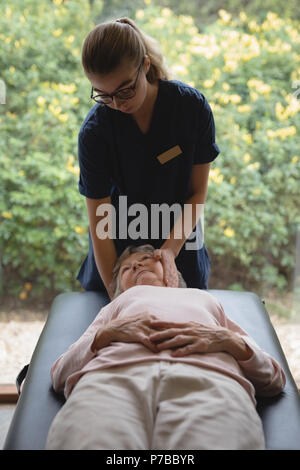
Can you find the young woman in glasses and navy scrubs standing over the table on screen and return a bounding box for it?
[77,18,219,298]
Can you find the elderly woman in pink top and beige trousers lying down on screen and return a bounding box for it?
[46,245,285,450]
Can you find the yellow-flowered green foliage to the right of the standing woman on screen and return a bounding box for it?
[137,7,300,288]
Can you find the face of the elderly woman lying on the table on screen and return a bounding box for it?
[119,252,166,291]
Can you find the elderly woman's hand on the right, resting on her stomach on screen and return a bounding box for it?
[149,320,232,357]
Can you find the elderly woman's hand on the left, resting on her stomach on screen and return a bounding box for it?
[91,311,159,353]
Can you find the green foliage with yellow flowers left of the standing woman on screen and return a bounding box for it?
[0,0,101,294]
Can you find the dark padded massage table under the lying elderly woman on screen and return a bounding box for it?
[4,290,300,450]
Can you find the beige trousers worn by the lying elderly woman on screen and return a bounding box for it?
[46,361,264,450]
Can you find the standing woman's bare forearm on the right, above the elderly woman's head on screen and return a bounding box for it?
[161,193,205,258]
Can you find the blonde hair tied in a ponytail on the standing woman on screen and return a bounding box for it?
[82,17,171,83]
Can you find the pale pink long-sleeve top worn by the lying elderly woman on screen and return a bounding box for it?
[51,285,286,405]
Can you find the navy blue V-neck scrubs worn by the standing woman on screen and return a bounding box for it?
[77,79,220,292]
